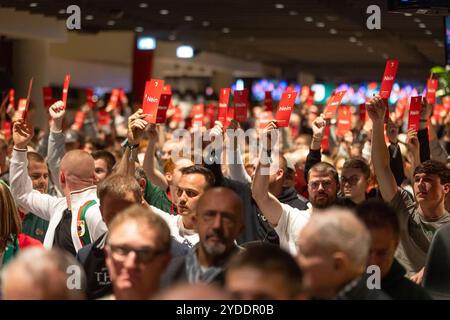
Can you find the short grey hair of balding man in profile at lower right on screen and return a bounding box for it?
[308,207,371,267]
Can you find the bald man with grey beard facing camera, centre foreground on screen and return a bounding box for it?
[162,187,244,286]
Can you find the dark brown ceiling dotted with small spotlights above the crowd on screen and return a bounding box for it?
[0,0,445,81]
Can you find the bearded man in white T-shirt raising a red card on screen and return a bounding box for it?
[252,122,339,255]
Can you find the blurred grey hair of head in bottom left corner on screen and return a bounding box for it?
[0,248,86,300]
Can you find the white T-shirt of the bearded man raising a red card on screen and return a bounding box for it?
[274,203,311,255]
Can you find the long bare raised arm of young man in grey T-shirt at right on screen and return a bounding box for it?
[366,96,397,202]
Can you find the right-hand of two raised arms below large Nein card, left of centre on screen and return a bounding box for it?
[143,124,169,190]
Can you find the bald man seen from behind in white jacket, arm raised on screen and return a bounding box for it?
[10,120,107,256]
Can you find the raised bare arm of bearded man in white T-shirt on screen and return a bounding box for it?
[252,121,283,227]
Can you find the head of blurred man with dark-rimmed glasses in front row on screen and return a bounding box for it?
[105,205,171,300]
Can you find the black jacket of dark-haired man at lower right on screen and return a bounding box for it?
[381,259,431,300]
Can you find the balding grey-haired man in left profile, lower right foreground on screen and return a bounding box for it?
[297,208,389,300]
